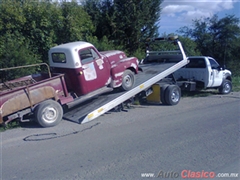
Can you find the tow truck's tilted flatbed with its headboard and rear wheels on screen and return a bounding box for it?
[63,37,188,124]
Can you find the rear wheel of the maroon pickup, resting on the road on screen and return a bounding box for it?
[35,100,63,127]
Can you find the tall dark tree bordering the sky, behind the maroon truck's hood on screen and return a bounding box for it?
[113,0,162,54]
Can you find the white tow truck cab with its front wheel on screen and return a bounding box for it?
[174,56,232,94]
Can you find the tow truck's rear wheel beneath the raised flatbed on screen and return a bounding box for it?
[165,85,181,105]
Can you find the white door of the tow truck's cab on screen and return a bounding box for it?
[208,58,223,87]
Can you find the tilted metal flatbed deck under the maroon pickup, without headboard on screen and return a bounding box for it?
[63,58,188,124]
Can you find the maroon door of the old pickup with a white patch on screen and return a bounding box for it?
[78,47,110,94]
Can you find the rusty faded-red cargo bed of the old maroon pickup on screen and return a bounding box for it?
[0,73,67,124]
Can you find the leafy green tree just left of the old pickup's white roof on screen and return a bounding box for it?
[21,0,61,62]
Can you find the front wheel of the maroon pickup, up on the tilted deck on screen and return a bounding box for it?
[121,69,135,91]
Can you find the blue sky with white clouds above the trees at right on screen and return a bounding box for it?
[159,0,240,35]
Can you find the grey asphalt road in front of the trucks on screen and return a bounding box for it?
[0,93,240,180]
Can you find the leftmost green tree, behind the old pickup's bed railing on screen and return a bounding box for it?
[0,0,39,80]
